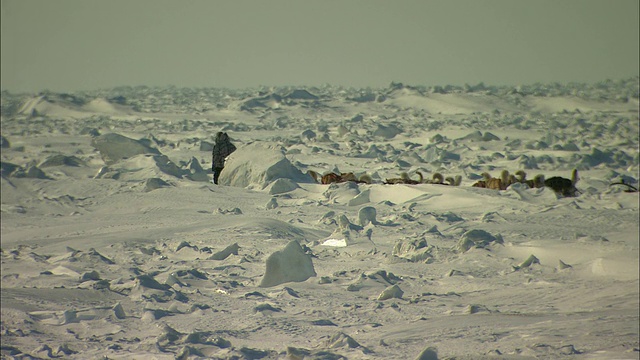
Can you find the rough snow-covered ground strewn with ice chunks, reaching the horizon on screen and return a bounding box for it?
[0,77,640,359]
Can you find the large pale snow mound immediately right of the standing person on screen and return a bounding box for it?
[218,143,310,190]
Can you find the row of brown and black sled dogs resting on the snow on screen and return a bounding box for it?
[307,169,580,197]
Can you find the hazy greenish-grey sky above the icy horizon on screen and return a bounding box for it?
[0,0,640,92]
